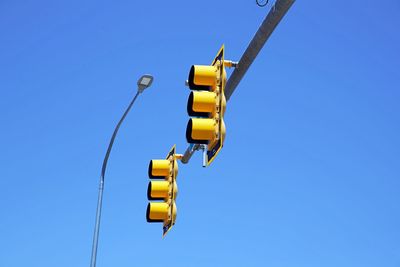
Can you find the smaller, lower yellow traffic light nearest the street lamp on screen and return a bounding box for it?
[146,146,181,236]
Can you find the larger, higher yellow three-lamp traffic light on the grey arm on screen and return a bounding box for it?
[186,45,227,165]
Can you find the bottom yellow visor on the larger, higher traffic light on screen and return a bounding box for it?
[186,118,217,144]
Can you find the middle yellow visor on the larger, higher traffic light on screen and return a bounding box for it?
[187,91,217,117]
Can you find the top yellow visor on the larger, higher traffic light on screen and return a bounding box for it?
[188,65,218,91]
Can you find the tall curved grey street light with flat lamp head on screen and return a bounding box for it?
[90,74,153,267]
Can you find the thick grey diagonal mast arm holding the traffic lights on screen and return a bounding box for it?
[181,0,295,163]
